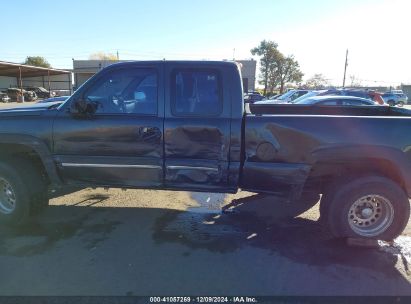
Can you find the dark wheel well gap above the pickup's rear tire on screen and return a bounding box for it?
[305,159,405,193]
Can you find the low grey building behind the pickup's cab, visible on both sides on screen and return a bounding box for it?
[73,60,257,91]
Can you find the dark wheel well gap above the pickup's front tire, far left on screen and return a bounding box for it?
[0,144,50,184]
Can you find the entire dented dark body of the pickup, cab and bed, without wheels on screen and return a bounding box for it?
[0,61,411,200]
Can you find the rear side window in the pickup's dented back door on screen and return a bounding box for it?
[171,70,222,116]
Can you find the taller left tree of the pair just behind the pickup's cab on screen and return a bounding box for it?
[251,40,279,95]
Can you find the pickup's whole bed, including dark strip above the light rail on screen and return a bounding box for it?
[242,105,411,196]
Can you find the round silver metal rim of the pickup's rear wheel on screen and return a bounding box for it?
[348,194,394,237]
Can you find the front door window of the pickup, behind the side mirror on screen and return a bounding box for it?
[84,68,157,115]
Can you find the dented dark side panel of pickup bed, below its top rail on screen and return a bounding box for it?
[241,115,411,192]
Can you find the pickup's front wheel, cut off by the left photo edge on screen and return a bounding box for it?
[0,160,30,226]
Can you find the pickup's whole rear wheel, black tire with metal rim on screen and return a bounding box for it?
[320,176,410,241]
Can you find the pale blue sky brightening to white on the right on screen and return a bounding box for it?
[0,0,411,86]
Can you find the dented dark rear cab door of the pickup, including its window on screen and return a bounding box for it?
[164,62,230,191]
